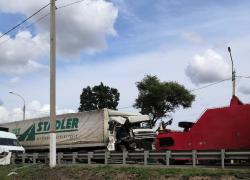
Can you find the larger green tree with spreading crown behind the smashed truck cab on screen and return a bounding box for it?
[133,75,195,126]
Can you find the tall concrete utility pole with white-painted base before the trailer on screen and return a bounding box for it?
[49,0,56,168]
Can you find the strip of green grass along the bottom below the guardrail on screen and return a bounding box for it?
[0,165,250,180]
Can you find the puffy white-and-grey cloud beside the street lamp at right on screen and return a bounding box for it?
[185,49,231,85]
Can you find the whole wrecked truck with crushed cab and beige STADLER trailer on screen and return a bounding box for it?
[0,109,155,152]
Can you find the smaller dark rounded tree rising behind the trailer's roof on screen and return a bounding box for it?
[78,82,120,112]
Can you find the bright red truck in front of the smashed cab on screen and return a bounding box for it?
[156,96,250,150]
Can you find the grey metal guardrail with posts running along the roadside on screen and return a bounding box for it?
[1,149,250,169]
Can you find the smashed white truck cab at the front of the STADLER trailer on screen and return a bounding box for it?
[107,110,155,151]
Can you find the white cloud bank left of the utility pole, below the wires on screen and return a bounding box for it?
[0,31,49,74]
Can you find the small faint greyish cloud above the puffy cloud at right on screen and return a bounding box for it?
[180,31,205,44]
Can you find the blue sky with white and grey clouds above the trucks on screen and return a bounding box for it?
[0,0,250,129]
